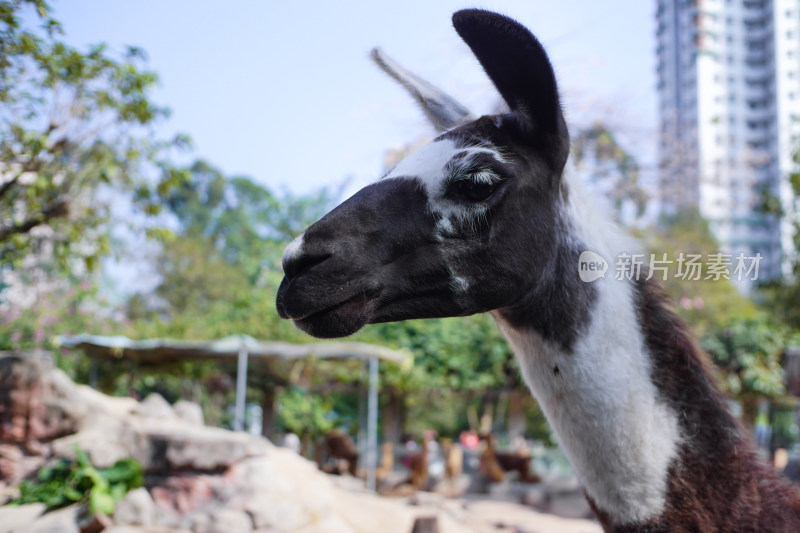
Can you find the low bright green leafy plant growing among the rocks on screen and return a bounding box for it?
[10,446,144,515]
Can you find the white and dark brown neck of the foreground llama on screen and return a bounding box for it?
[493,171,800,531]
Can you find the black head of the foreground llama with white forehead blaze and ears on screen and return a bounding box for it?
[277,10,585,343]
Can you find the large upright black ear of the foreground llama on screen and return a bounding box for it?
[453,9,566,135]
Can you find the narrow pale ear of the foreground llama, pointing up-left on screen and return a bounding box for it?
[370,48,474,132]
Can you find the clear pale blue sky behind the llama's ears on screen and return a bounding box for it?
[53,0,657,197]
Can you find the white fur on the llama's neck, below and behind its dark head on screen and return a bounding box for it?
[495,169,681,525]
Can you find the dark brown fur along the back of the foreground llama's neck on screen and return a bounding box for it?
[590,281,800,533]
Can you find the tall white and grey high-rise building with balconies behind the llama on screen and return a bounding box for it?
[656,0,800,279]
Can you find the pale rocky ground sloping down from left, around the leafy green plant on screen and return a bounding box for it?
[0,354,600,533]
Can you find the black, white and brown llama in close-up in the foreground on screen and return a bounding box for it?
[276,10,800,532]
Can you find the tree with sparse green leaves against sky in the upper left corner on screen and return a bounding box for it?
[0,0,188,270]
